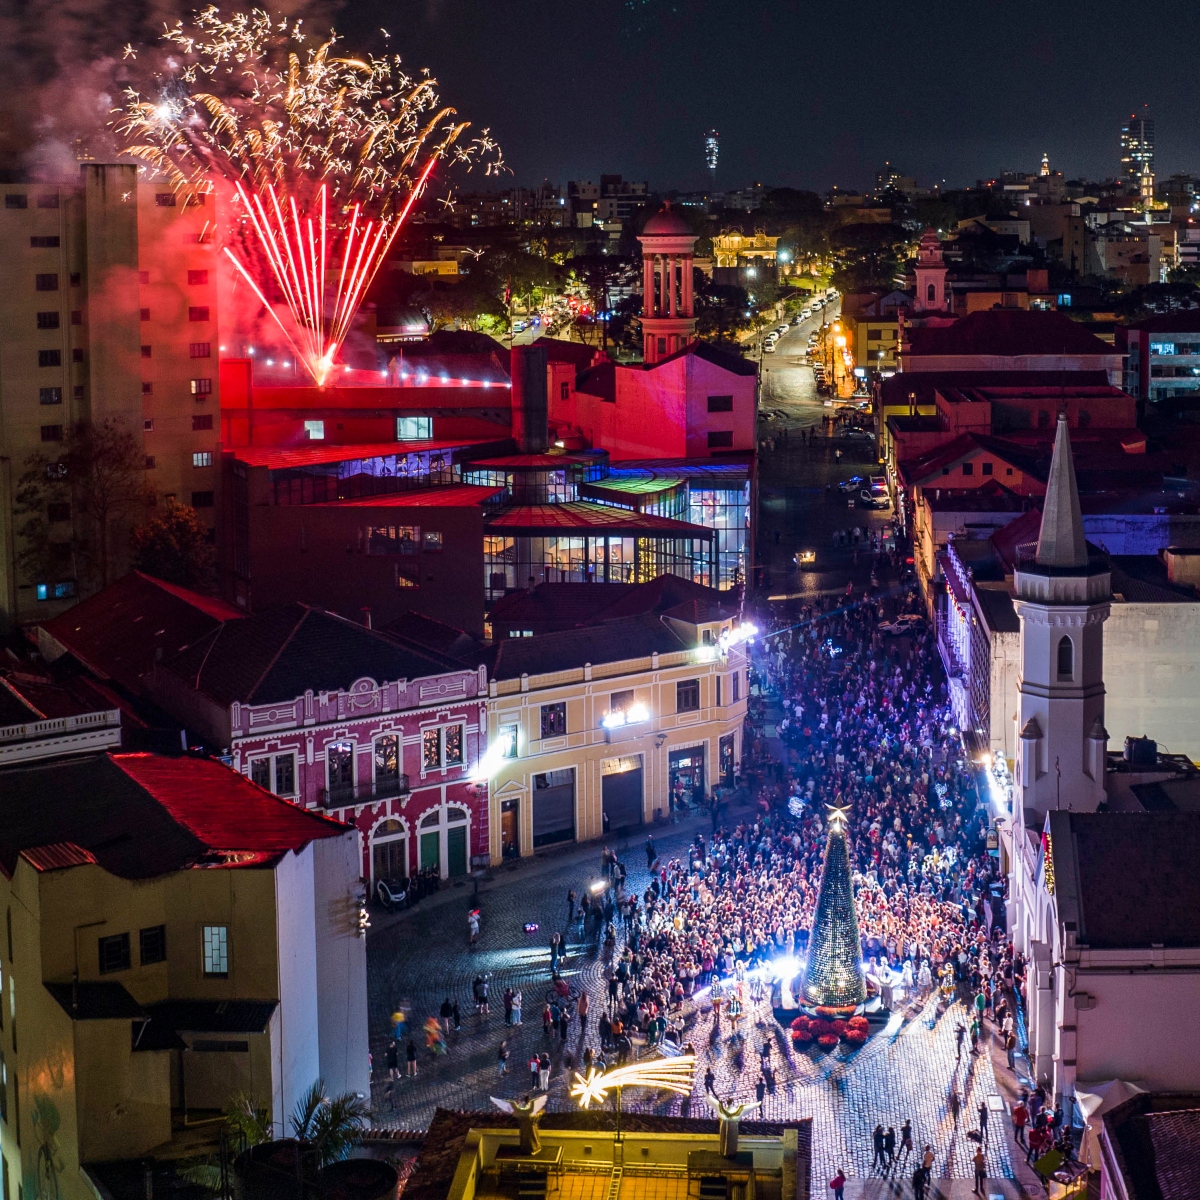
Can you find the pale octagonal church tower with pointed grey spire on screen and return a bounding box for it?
[1014,413,1112,832]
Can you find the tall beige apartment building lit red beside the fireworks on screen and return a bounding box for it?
[0,162,220,628]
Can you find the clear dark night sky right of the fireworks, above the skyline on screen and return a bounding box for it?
[337,0,1200,190]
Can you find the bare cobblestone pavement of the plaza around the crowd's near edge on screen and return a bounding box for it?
[368,809,1014,1180]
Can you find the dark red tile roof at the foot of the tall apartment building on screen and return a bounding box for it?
[38,571,246,694]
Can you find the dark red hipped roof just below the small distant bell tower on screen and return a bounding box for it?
[905,308,1120,361]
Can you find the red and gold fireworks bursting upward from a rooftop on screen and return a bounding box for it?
[116,7,502,384]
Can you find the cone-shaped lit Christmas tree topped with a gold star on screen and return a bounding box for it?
[804,805,866,1010]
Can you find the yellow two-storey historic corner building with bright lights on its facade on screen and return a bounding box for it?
[480,601,754,863]
